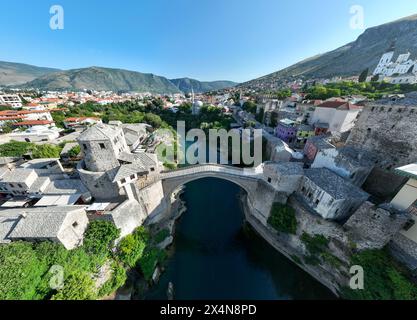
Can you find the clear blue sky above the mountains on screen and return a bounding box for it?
[0,0,417,81]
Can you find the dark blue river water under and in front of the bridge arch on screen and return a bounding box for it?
[146,178,335,300]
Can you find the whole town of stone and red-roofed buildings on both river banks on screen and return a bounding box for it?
[0,79,417,293]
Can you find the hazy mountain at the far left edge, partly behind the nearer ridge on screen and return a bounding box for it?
[0,61,59,86]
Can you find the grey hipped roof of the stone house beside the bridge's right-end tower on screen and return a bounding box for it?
[304,168,369,199]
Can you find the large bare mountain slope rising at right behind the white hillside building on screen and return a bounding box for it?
[241,14,417,87]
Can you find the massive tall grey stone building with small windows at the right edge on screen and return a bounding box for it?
[346,92,417,199]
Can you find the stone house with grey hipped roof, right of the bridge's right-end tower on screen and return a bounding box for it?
[297,168,369,220]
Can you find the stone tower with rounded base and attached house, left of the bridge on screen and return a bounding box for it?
[78,124,160,200]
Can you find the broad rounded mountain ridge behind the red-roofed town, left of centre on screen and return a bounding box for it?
[23,67,180,94]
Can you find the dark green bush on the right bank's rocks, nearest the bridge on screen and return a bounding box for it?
[268,203,297,234]
